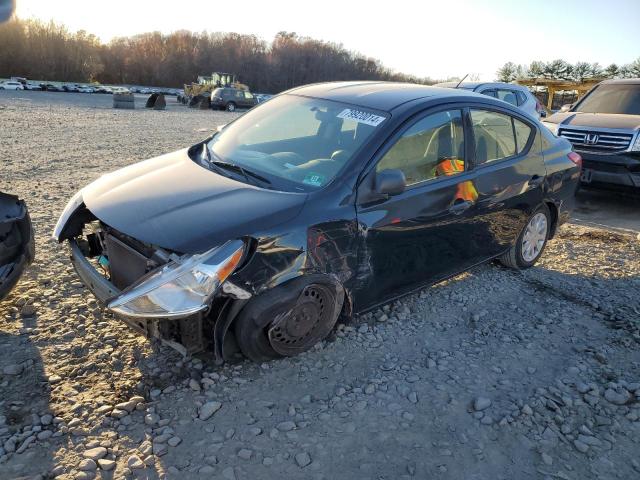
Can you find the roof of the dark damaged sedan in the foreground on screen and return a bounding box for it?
[285,82,469,112]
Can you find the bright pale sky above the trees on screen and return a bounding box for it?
[16,0,640,80]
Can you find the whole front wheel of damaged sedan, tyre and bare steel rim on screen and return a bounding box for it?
[235,275,344,362]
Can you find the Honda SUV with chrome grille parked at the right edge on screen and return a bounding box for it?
[543,78,640,191]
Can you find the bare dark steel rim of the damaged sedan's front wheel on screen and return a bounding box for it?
[268,285,334,355]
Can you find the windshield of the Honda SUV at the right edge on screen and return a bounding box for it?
[573,84,640,115]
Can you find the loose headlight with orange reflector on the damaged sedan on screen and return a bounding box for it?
[108,240,244,318]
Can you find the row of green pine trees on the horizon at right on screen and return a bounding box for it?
[496,57,640,82]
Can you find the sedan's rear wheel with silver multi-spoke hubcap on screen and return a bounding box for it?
[499,205,551,269]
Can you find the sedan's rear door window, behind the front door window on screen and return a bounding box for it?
[471,110,516,164]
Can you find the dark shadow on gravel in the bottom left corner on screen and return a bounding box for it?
[0,330,54,478]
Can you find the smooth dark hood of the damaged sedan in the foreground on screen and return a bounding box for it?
[82,149,307,253]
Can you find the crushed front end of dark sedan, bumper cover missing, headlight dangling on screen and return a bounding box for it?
[53,196,250,359]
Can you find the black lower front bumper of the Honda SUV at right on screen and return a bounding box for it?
[578,151,640,189]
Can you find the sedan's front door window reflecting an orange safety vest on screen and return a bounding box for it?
[376,110,465,185]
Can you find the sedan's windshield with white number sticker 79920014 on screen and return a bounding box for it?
[208,95,386,191]
